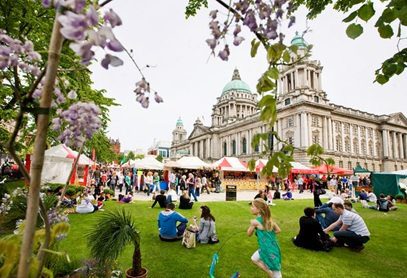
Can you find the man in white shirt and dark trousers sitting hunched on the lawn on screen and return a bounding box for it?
[324,204,370,252]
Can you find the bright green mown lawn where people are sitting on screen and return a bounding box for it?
[61,200,407,278]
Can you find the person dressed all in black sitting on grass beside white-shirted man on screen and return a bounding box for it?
[293,207,332,251]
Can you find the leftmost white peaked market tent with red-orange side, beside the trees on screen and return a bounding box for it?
[41,144,93,185]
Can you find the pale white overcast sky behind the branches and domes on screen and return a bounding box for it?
[91,0,407,151]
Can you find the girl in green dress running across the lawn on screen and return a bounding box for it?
[247,198,282,278]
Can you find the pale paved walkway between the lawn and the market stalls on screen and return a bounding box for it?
[116,190,328,202]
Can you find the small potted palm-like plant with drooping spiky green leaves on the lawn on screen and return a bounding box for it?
[87,208,148,278]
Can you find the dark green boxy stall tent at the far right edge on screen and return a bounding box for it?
[371,173,407,196]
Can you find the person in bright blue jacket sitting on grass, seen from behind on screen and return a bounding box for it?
[158,203,188,241]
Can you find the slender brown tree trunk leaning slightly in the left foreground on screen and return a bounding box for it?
[18,12,63,278]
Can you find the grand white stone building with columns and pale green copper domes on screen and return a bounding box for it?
[171,36,407,171]
